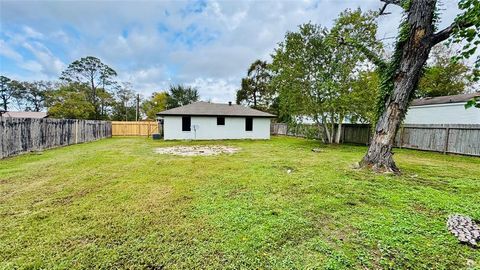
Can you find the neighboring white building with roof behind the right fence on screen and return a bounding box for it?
[404,93,480,124]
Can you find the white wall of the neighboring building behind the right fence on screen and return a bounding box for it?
[404,103,480,124]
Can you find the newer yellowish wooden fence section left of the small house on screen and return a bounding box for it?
[112,121,159,136]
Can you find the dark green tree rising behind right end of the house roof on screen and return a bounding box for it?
[236,60,274,110]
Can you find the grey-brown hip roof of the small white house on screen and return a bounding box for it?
[157,101,275,117]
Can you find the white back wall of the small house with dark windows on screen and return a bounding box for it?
[163,116,270,140]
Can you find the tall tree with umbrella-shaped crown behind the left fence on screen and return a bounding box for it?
[60,56,117,119]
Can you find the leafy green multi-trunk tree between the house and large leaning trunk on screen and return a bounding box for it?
[271,10,381,142]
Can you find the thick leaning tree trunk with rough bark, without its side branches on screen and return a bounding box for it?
[360,0,436,173]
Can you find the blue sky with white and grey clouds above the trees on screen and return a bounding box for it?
[0,0,459,102]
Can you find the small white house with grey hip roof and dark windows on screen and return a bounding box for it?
[157,101,275,140]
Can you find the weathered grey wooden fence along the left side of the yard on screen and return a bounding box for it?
[0,117,112,158]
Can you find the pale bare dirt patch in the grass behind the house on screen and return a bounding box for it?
[155,145,239,157]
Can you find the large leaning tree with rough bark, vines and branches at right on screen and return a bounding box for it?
[356,0,480,173]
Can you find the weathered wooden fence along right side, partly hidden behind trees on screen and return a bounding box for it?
[271,123,480,156]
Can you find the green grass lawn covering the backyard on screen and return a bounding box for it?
[0,137,480,269]
